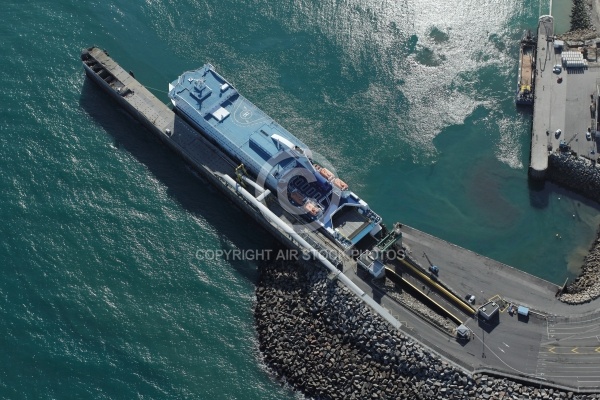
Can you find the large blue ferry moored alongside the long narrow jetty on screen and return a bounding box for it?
[169,64,385,250]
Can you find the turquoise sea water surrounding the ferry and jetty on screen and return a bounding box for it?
[0,0,600,399]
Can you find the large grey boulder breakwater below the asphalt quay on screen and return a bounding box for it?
[255,263,598,400]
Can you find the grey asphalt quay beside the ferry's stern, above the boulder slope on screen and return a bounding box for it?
[345,226,600,388]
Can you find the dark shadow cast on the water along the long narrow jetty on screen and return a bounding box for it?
[79,77,280,283]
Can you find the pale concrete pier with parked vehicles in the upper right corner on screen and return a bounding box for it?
[529,16,600,179]
